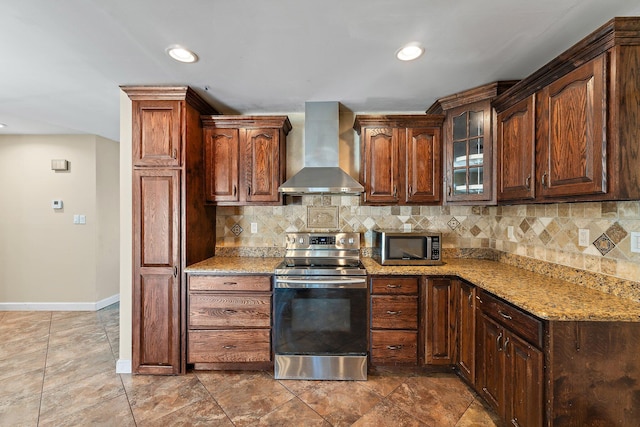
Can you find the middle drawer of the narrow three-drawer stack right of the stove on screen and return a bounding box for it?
[371,296,418,329]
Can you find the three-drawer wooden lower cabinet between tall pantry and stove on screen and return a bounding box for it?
[187,275,272,369]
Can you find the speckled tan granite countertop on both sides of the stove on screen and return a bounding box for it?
[186,257,640,322]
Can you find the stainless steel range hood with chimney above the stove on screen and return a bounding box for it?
[278,102,364,195]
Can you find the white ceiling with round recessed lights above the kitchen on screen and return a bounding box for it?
[0,0,640,140]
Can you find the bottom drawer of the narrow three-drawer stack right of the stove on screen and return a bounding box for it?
[371,331,418,365]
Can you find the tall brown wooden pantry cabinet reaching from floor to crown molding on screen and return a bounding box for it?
[122,86,217,375]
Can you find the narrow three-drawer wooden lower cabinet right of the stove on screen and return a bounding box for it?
[369,276,422,366]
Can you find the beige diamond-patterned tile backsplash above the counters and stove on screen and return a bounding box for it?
[216,196,640,294]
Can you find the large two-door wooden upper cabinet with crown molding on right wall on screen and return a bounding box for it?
[492,17,640,203]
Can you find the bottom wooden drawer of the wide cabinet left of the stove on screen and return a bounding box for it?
[187,329,271,363]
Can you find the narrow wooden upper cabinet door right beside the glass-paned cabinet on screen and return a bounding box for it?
[496,96,536,201]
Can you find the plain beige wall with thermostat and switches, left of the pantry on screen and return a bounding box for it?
[0,135,119,309]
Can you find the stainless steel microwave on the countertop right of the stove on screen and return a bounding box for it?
[372,230,442,265]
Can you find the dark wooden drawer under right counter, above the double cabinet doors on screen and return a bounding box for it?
[479,291,542,348]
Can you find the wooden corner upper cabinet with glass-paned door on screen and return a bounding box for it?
[427,81,515,205]
